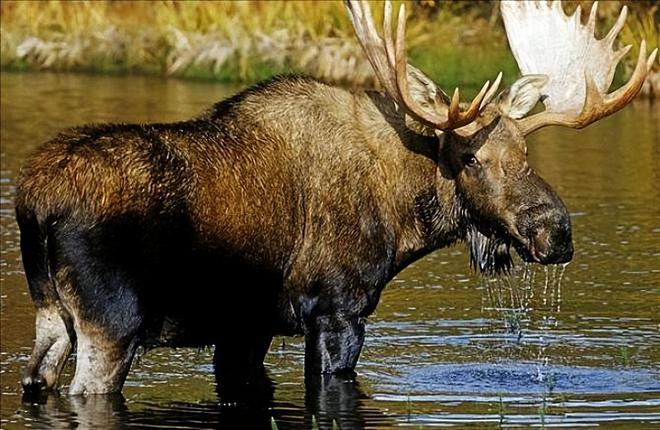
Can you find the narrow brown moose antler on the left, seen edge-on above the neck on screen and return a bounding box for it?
[345,0,501,130]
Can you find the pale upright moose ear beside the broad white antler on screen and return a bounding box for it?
[497,75,548,119]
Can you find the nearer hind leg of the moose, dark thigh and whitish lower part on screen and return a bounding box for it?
[49,223,147,395]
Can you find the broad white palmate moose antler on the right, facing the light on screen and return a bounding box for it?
[500,0,658,135]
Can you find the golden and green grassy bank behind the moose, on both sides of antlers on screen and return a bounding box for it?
[0,0,660,92]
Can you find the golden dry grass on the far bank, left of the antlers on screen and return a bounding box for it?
[2,2,376,81]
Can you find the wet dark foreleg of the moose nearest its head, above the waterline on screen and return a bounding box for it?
[305,314,364,376]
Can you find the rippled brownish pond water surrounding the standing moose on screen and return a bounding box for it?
[0,74,660,429]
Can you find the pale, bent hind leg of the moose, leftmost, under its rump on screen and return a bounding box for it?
[21,305,71,393]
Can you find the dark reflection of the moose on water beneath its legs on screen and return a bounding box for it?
[16,375,393,429]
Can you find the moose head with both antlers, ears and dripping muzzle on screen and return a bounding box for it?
[346,0,657,272]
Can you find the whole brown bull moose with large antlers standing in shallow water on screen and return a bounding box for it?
[16,0,657,395]
